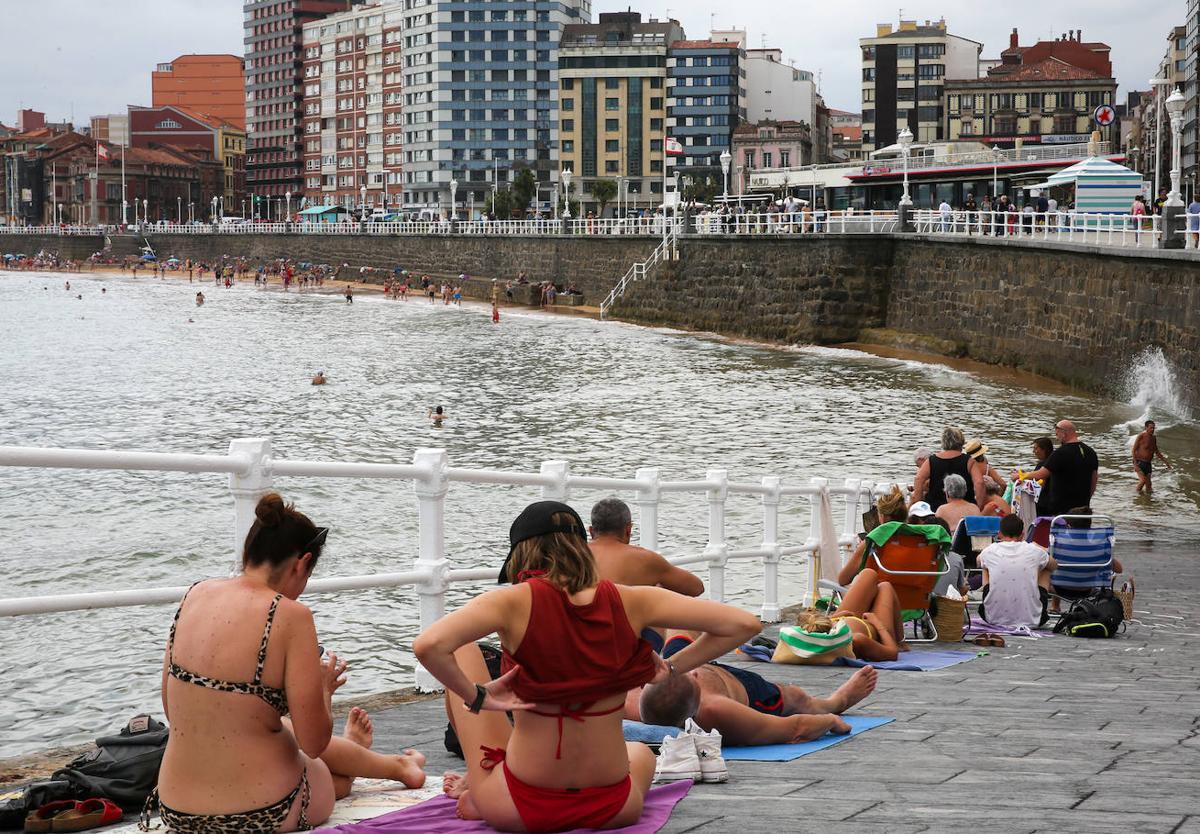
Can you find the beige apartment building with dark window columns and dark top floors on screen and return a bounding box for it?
[558,12,681,211]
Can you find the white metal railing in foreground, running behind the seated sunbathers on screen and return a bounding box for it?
[0,439,874,690]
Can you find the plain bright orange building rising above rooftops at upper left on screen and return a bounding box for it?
[150,55,246,131]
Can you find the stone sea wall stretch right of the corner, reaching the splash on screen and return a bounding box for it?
[887,239,1200,403]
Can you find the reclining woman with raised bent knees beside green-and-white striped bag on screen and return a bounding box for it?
[796,568,908,661]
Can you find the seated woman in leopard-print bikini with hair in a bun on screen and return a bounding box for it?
[140,493,425,834]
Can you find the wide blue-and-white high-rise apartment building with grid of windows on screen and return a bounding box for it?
[402,0,592,214]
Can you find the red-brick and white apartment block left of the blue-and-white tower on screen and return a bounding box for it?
[298,2,404,210]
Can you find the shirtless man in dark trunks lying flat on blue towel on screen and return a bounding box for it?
[625,631,878,746]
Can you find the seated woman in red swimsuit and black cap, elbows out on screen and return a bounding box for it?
[413,502,762,832]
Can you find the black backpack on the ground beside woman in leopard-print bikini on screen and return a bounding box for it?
[52,715,169,810]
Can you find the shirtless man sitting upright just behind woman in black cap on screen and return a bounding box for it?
[588,498,704,596]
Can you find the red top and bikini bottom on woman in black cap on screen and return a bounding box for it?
[484,577,655,833]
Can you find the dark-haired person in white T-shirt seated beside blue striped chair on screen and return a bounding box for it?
[979,516,1055,628]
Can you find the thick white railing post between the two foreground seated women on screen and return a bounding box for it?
[413,449,450,692]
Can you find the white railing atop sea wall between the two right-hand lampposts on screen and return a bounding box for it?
[913,209,1163,248]
